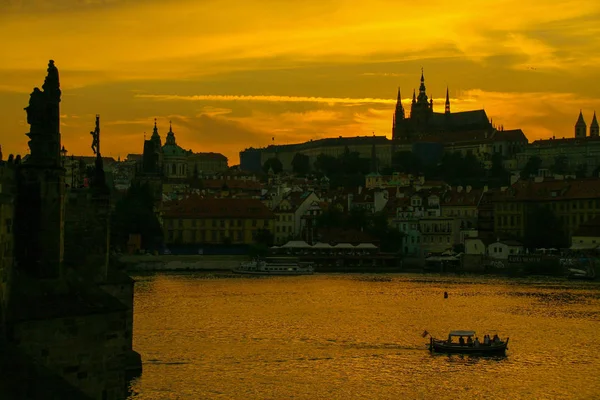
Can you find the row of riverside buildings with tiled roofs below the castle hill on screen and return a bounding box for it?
[155,168,600,258]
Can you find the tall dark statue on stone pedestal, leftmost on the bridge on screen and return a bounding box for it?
[15,60,65,281]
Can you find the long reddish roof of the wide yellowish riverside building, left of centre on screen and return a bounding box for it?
[163,196,275,219]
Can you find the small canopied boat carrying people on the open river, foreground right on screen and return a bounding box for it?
[426,330,509,355]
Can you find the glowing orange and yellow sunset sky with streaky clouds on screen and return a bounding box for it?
[0,0,600,165]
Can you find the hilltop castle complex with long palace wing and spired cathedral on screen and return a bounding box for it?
[240,72,528,171]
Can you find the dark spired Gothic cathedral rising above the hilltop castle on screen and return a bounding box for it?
[392,70,493,143]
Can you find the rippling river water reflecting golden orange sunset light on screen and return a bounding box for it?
[132,274,600,400]
